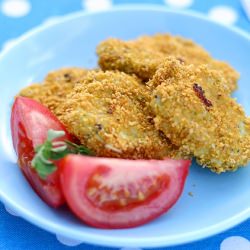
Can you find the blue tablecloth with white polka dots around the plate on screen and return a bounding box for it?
[0,0,250,250]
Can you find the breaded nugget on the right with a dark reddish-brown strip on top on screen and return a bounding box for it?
[148,58,250,173]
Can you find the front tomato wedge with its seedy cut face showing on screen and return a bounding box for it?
[60,155,190,228]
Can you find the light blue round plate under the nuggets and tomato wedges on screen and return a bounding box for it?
[0,6,250,247]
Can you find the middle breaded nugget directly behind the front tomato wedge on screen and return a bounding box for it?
[57,71,181,159]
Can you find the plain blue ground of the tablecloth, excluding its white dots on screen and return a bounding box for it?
[0,0,250,250]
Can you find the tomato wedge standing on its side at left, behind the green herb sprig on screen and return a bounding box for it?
[11,97,72,207]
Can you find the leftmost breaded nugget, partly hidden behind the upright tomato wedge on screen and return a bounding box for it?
[19,68,87,116]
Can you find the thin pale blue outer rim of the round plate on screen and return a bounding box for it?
[0,4,250,248]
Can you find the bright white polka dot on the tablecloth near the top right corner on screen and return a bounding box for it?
[208,6,238,25]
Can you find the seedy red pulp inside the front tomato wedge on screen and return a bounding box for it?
[86,167,170,211]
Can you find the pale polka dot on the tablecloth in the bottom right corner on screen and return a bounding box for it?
[220,236,250,250]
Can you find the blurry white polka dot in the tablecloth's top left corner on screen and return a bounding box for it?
[1,0,31,17]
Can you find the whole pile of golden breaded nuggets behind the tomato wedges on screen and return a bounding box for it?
[19,34,250,173]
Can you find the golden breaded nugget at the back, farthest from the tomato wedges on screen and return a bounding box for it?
[97,34,239,92]
